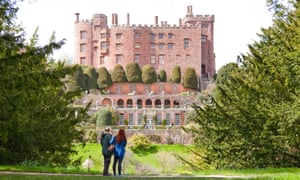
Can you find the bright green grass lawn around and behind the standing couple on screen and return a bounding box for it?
[0,144,300,180]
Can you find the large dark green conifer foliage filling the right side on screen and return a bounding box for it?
[186,2,300,168]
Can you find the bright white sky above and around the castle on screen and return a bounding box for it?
[17,0,272,70]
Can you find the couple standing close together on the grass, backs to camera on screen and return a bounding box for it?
[101,127,127,176]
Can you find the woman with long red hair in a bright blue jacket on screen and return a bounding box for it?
[110,129,127,176]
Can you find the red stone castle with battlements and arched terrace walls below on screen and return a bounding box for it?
[74,6,215,125]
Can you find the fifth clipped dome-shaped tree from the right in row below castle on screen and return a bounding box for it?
[126,62,142,82]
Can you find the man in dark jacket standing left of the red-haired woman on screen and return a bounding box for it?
[101,127,112,176]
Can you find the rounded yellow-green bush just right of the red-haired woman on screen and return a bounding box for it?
[128,134,151,151]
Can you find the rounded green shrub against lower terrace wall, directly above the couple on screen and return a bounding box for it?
[93,108,112,126]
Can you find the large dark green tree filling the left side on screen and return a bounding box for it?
[0,0,86,165]
